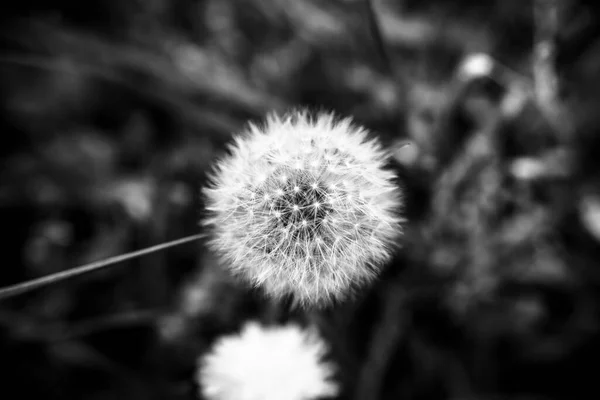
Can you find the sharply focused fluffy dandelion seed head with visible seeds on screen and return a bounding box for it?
[203,112,402,305]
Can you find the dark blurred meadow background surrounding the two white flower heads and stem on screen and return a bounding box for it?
[0,0,600,400]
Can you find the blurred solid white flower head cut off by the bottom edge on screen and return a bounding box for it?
[197,322,339,400]
